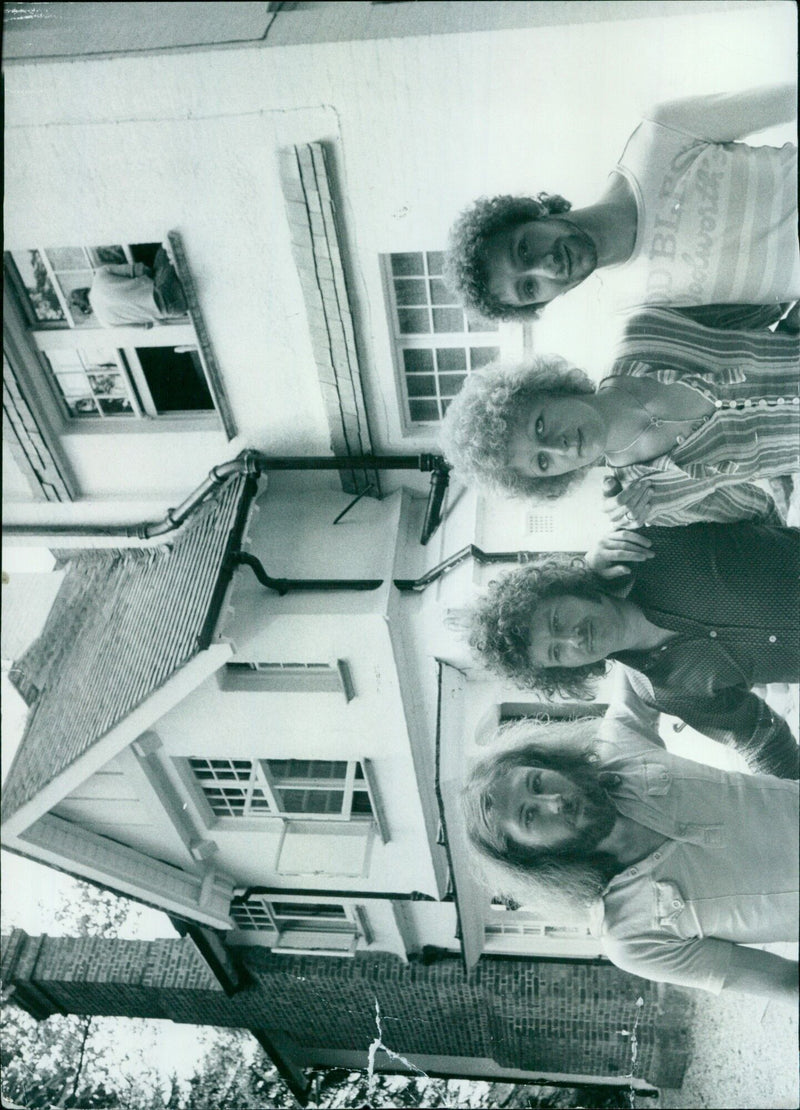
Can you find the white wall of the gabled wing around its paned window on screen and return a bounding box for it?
[152,648,435,894]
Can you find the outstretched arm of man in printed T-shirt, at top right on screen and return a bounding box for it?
[645,84,797,142]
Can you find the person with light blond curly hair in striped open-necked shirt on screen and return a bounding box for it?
[443,307,800,525]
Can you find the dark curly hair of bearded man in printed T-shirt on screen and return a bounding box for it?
[444,193,573,320]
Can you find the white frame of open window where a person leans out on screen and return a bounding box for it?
[6,243,221,435]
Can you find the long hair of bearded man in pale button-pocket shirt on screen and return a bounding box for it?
[460,718,618,906]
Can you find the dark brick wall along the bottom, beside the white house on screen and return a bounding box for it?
[2,930,691,1087]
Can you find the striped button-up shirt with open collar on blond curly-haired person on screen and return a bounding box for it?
[599,307,800,525]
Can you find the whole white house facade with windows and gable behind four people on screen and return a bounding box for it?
[3,0,794,1061]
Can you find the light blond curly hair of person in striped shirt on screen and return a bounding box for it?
[440,355,596,498]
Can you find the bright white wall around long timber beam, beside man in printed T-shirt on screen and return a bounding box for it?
[6,3,794,508]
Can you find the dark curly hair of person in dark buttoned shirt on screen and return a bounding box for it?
[469,553,607,699]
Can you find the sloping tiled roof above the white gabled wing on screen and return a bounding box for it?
[2,475,249,817]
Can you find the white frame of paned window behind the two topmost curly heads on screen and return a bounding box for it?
[378,249,508,436]
